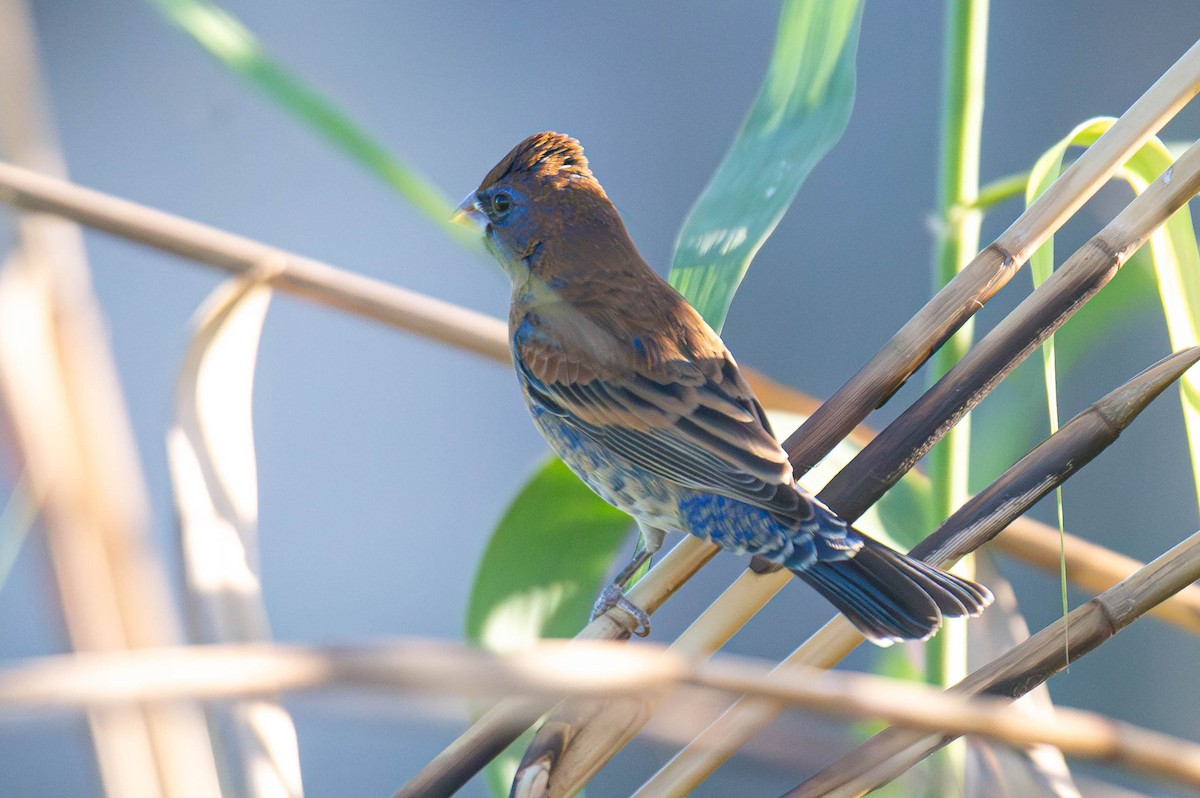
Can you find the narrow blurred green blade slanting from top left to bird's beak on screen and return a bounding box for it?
[142,0,482,252]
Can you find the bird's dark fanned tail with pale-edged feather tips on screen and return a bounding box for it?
[792,533,992,646]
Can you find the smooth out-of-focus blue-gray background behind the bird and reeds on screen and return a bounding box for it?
[0,0,1200,796]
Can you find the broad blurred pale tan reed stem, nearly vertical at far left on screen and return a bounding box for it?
[0,0,220,797]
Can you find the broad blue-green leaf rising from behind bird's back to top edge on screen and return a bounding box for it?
[670,0,862,330]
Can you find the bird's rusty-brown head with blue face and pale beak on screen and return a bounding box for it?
[452,131,625,282]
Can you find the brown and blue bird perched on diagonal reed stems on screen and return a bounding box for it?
[452,131,992,646]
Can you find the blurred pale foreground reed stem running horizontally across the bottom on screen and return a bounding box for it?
[0,641,1200,785]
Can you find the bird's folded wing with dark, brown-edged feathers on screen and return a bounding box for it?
[512,300,814,523]
